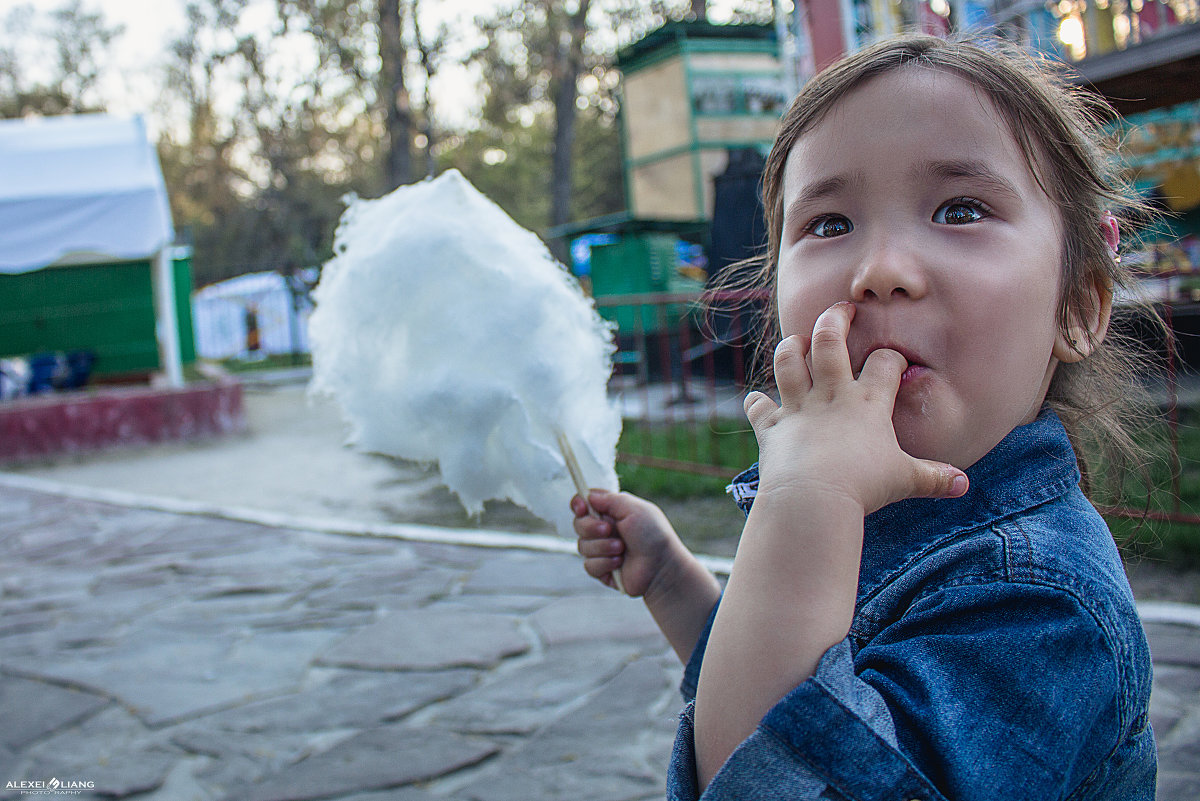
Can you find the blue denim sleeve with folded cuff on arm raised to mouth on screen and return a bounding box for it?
[668,583,1132,801]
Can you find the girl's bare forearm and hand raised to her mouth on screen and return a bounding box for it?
[695,303,967,787]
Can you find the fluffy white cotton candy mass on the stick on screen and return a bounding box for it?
[308,170,620,551]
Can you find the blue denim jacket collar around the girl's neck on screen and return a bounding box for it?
[728,406,1080,597]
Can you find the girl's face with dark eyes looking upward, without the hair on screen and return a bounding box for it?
[778,67,1062,469]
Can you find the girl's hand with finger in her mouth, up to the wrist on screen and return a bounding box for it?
[745,302,967,514]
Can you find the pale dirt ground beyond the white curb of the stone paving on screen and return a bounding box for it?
[10,380,1200,603]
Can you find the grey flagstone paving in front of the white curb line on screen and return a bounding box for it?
[0,484,1200,801]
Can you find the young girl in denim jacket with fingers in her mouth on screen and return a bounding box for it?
[572,37,1156,801]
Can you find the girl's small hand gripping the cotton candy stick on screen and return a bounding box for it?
[571,489,686,598]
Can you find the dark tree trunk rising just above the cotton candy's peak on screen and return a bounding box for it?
[379,0,413,192]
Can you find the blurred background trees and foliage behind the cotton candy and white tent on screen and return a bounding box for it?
[0,0,770,284]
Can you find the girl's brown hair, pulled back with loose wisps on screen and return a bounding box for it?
[718,35,1162,489]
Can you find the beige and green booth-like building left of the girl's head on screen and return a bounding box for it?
[550,22,788,333]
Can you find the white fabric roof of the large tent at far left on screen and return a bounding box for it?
[0,114,174,272]
